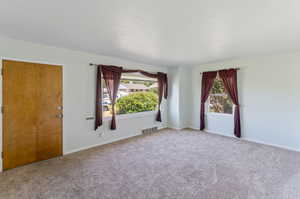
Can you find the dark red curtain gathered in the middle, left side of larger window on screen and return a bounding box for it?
[101,65,122,130]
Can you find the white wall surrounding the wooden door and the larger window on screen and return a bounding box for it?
[0,36,167,171]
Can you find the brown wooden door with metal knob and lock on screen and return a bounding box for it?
[3,60,62,170]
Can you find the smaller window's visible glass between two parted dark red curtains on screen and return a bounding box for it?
[208,77,233,114]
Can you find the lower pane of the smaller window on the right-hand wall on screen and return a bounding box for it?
[209,95,233,114]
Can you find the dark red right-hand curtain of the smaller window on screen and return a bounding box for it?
[219,69,241,138]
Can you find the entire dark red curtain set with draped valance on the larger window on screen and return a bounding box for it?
[95,65,168,130]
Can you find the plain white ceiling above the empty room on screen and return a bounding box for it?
[0,0,300,66]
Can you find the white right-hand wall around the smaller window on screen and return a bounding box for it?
[187,53,300,150]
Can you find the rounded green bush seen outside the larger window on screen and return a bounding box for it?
[116,92,158,114]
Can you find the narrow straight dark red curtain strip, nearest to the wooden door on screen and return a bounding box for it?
[95,66,102,130]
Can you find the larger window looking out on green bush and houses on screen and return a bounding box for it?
[102,73,158,117]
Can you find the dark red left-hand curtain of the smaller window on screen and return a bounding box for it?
[200,71,218,130]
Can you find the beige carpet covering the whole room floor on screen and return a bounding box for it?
[0,130,300,199]
